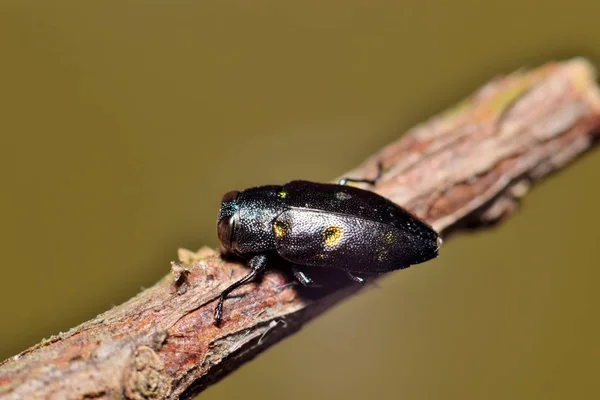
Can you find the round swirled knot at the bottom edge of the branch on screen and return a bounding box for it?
[123,346,171,400]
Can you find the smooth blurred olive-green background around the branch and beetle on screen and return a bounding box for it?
[0,0,600,400]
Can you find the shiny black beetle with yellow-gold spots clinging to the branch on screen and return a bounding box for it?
[214,164,442,325]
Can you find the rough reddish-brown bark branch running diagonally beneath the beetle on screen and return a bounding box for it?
[0,59,600,400]
